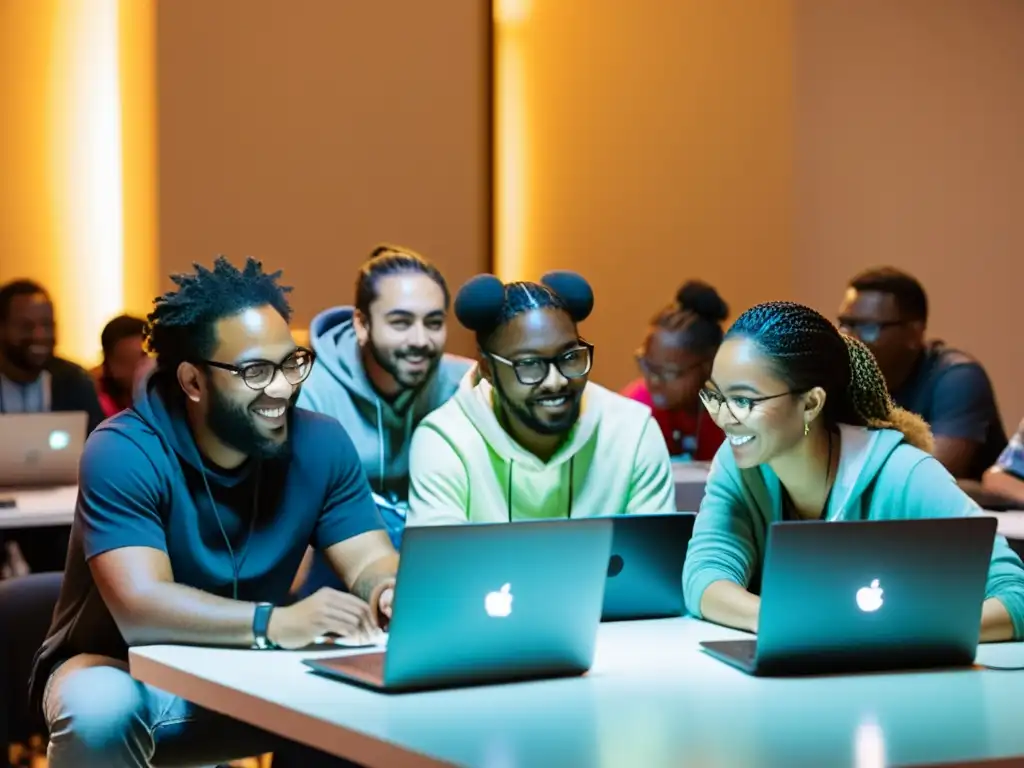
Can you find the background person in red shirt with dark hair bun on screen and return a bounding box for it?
[622,281,729,461]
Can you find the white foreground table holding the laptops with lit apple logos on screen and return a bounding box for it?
[130,618,1024,768]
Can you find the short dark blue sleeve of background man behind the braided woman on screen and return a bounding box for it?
[931,362,999,442]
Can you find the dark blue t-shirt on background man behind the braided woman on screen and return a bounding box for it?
[892,341,1007,480]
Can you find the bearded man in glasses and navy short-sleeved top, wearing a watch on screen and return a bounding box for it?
[31,257,397,768]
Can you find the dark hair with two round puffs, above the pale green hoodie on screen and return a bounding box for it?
[455,271,594,349]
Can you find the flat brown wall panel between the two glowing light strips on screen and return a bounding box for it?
[157,0,490,351]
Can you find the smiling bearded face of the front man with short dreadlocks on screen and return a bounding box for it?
[193,306,299,459]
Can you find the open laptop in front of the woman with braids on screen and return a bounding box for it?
[700,516,996,675]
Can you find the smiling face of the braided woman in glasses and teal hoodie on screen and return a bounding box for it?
[702,337,824,469]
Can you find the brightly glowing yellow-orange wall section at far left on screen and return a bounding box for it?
[0,0,156,365]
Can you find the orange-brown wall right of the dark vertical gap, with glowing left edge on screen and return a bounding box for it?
[520,0,1024,434]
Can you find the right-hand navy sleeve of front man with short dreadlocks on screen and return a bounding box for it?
[312,421,384,551]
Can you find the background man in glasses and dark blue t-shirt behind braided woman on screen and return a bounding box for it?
[839,267,1007,480]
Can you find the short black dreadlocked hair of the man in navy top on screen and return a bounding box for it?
[144,256,292,373]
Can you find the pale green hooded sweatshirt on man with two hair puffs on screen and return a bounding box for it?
[409,373,675,525]
